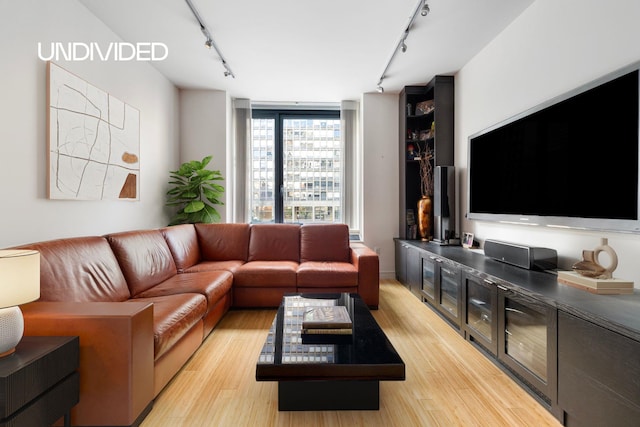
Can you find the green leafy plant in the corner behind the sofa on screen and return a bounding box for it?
[166,156,224,225]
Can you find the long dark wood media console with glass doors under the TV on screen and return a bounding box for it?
[396,239,640,426]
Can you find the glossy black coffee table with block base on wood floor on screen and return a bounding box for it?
[256,293,405,411]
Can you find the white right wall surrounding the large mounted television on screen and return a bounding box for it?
[455,0,640,287]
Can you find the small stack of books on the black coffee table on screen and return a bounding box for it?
[302,305,353,335]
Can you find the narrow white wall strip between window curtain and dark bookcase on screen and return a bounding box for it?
[361,93,400,278]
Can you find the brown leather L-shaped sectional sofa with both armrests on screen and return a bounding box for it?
[13,224,379,426]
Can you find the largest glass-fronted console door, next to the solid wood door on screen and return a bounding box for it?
[498,285,558,408]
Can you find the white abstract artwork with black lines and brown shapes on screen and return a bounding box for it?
[47,62,140,200]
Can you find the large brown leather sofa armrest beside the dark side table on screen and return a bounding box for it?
[21,302,154,425]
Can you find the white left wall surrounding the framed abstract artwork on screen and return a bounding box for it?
[0,0,178,247]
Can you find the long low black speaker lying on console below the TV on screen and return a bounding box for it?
[484,239,558,270]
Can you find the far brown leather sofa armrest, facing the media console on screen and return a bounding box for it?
[350,243,380,309]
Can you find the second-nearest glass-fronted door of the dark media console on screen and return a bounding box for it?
[462,273,498,356]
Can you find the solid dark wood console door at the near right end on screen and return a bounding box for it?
[558,311,640,427]
